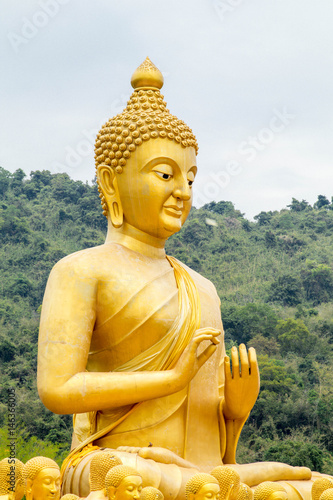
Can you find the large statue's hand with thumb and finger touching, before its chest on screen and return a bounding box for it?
[173,328,221,388]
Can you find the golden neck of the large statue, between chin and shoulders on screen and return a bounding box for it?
[105,220,166,259]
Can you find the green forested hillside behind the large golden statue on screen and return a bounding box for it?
[0,168,333,474]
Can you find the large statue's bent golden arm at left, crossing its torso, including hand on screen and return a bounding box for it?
[37,260,217,414]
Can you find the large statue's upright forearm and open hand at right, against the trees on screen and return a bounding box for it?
[220,344,260,464]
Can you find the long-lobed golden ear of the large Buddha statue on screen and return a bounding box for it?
[97,165,124,227]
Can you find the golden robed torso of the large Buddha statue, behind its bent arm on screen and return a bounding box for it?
[68,249,224,470]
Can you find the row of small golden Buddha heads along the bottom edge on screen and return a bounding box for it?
[0,451,333,500]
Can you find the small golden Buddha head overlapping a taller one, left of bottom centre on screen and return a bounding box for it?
[105,465,142,500]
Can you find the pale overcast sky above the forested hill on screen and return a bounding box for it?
[0,0,333,217]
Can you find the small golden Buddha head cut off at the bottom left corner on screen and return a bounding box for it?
[0,458,24,500]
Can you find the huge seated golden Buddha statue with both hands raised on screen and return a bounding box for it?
[38,58,320,500]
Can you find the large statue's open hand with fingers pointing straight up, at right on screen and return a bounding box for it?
[223,344,260,420]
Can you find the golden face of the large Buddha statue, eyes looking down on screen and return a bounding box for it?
[116,138,197,239]
